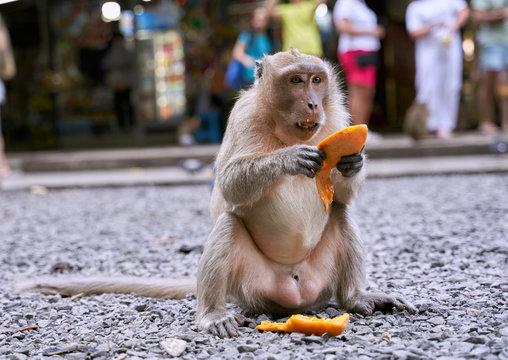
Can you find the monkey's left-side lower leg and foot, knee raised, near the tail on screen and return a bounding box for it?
[196,213,253,338]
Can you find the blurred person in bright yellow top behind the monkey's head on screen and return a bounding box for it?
[265,0,325,57]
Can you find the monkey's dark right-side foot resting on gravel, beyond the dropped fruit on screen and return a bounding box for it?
[351,294,416,316]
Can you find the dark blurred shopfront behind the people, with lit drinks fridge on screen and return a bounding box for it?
[0,0,480,151]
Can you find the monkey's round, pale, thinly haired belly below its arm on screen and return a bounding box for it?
[243,175,328,265]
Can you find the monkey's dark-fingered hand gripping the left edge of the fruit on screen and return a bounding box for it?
[281,145,326,178]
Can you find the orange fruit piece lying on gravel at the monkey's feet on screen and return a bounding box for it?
[256,313,349,336]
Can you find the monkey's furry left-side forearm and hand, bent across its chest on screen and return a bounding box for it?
[217,145,325,205]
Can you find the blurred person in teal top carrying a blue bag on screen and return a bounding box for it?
[233,7,272,85]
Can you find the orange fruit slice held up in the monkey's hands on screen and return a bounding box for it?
[316,125,368,212]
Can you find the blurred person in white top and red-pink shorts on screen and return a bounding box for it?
[333,0,385,141]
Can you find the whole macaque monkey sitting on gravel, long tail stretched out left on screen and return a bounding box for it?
[20,49,416,337]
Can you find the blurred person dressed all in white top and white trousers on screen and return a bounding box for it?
[406,0,469,138]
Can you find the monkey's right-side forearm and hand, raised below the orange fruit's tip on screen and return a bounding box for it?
[332,149,365,204]
